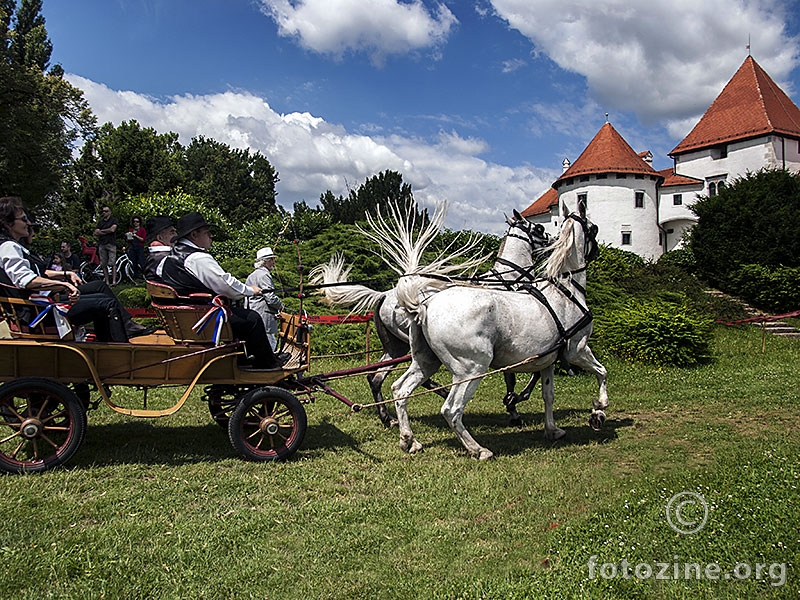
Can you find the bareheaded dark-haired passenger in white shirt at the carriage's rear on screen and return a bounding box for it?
[0,196,149,342]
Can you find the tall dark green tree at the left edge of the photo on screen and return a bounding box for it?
[0,0,96,207]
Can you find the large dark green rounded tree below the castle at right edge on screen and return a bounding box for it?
[690,170,800,287]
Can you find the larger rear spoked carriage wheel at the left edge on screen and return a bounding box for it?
[0,377,86,473]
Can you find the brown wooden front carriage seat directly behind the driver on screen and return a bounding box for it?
[146,281,233,344]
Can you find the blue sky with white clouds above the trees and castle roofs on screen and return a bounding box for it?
[43,0,800,233]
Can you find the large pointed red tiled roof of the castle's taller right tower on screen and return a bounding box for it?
[669,56,800,156]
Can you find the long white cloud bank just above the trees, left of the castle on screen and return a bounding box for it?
[67,75,557,234]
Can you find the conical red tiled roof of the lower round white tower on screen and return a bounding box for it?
[553,123,657,187]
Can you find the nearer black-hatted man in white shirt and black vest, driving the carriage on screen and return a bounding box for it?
[156,212,288,370]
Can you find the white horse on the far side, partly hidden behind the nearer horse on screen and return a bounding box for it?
[309,210,551,427]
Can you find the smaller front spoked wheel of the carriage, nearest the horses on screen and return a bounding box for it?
[228,387,307,462]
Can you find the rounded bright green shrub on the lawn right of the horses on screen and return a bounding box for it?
[601,300,711,367]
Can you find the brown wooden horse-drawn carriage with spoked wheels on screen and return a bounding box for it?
[0,284,324,473]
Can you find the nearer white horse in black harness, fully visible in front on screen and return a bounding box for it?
[364,202,608,460]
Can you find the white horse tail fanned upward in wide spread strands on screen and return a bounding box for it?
[357,202,488,322]
